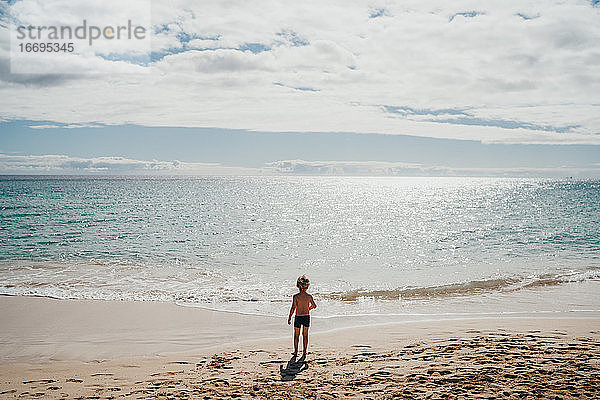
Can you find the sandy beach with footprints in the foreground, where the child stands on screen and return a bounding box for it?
[0,296,600,399]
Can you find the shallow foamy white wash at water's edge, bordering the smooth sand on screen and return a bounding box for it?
[0,267,600,328]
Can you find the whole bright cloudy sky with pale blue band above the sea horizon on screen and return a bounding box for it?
[0,0,600,177]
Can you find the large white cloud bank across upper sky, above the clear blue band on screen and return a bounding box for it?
[0,0,600,144]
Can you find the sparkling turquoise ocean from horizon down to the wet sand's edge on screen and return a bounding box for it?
[0,176,600,318]
